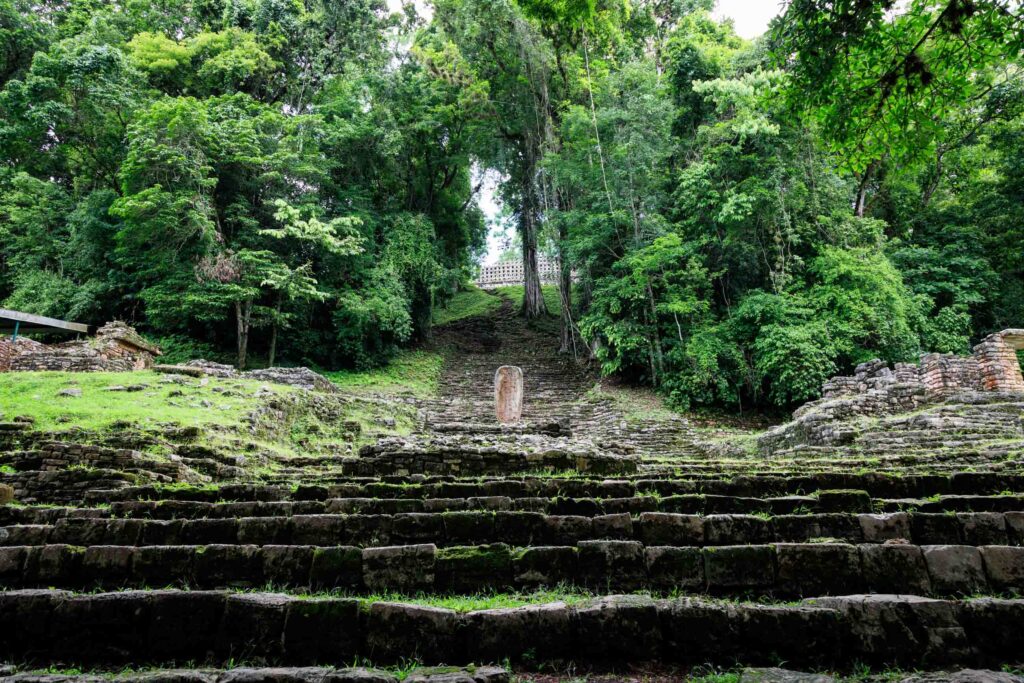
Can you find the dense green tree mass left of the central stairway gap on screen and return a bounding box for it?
[0,0,483,366]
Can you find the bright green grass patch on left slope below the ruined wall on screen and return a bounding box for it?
[0,372,296,430]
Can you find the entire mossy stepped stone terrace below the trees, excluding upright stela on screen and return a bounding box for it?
[0,294,1024,683]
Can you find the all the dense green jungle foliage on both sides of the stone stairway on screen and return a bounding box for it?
[0,0,1024,408]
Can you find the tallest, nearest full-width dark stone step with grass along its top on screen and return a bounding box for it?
[0,590,1024,668]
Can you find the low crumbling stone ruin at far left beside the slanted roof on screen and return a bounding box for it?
[0,322,160,373]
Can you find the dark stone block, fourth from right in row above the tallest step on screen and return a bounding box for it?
[775,543,863,596]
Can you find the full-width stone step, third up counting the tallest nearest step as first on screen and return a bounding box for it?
[0,511,1024,547]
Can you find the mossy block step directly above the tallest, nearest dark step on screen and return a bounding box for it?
[0,541,1024,598]
